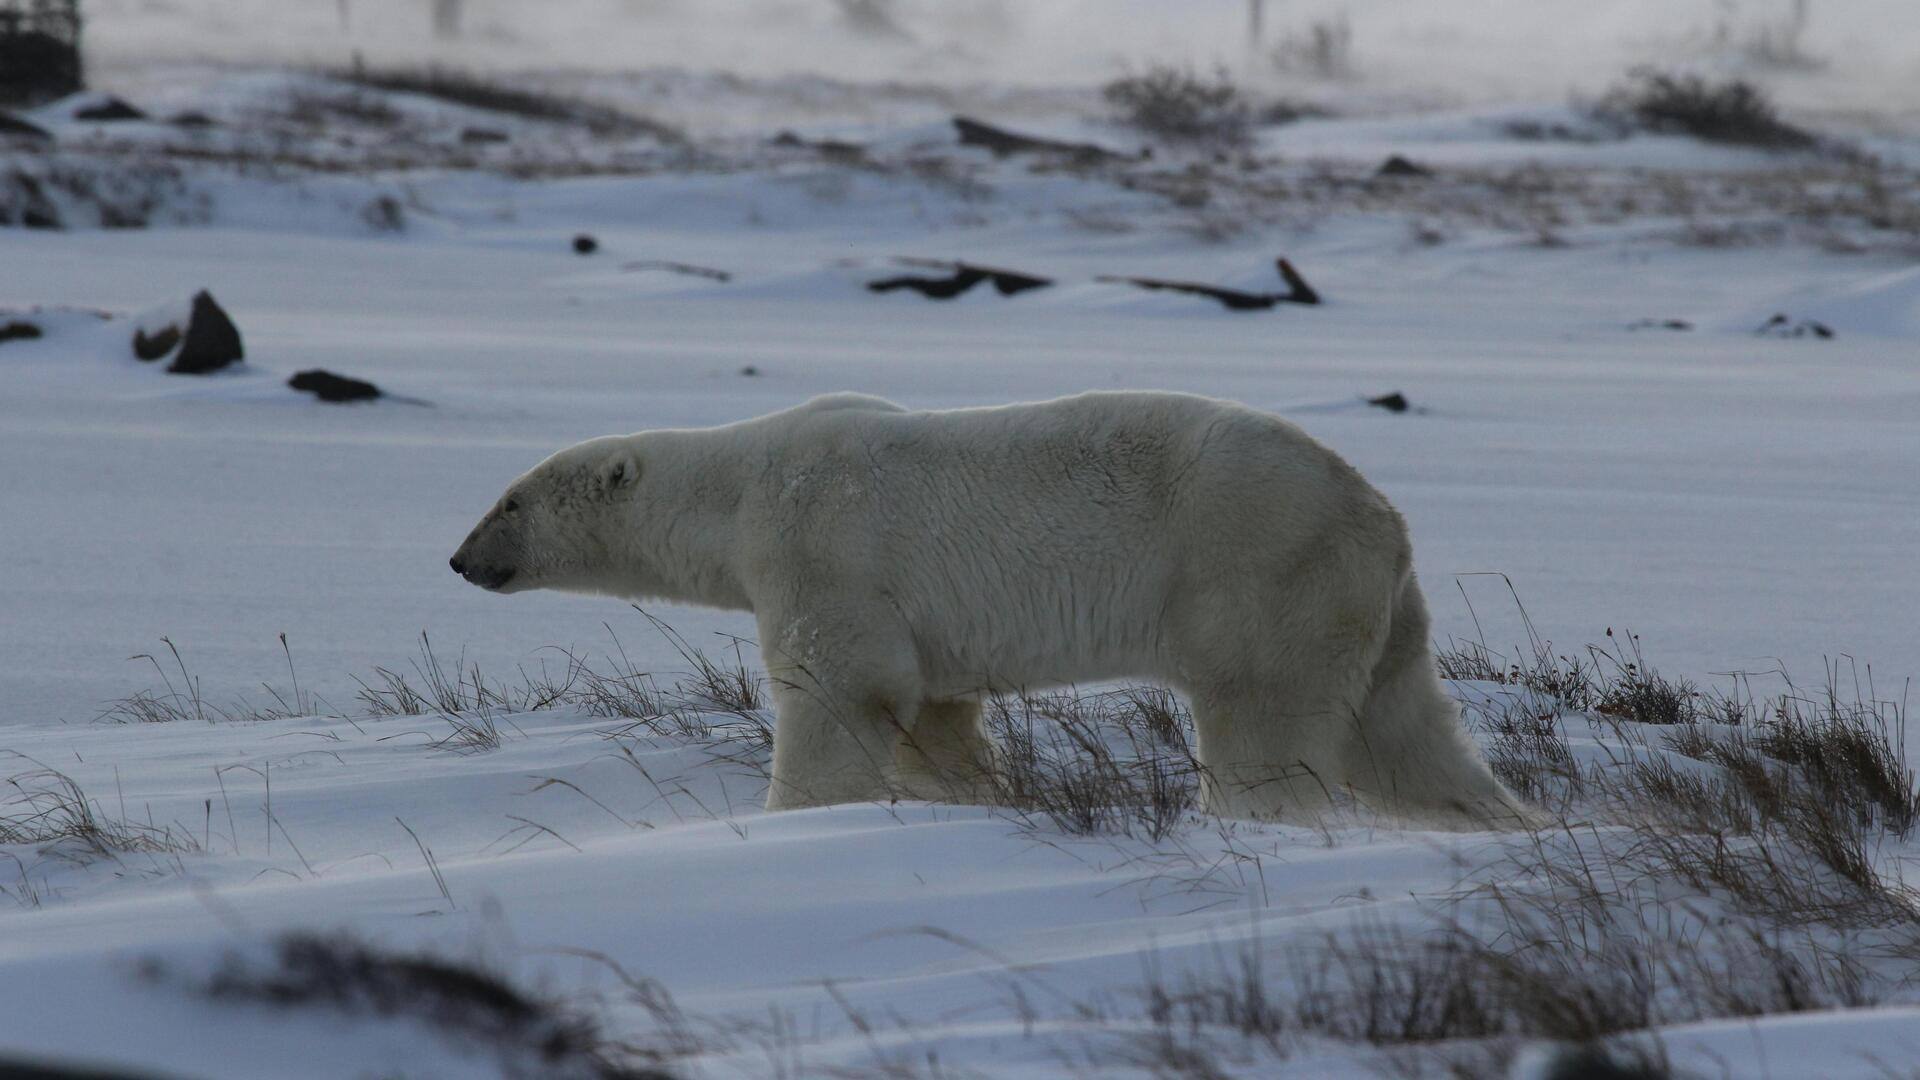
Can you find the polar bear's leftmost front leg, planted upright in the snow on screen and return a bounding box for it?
[758,603,922,811]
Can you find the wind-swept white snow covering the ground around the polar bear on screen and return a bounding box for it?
[0,12,1920,1076]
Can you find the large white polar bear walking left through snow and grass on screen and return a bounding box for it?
[449,392,1526,826]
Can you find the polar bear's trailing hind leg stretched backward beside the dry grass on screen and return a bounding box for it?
[1348,569,1540,828]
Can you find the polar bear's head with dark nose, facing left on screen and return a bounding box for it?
[447,436,641,592]
